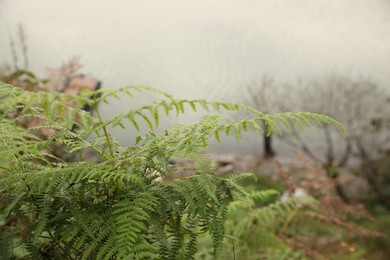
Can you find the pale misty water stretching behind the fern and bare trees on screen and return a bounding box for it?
[0,0,390,157]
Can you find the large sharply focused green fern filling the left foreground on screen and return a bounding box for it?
[0,83,344,259]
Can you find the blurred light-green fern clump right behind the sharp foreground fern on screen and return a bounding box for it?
[197,190,315,260]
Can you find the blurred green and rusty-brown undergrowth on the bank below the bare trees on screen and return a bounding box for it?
[196,164,388,260]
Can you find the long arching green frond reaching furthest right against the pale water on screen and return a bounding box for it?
[100,94,345,140]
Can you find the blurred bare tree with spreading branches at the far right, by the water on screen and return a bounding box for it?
[284,75,390,200]
